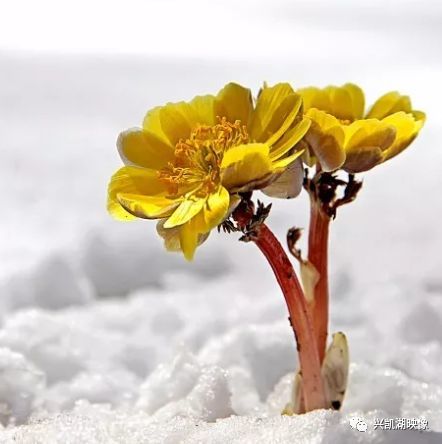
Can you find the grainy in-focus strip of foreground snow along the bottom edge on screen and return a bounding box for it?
[1,402,441,444]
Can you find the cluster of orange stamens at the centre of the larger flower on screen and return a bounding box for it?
[159,117,249,196]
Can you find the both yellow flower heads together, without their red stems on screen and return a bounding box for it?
[108,83,425,259]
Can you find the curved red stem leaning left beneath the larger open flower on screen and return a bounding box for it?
[252,224,328,411]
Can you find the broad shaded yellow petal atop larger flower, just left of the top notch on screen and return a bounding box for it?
[215,83,253,126]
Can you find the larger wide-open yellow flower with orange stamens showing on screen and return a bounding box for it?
[108,83,310,259]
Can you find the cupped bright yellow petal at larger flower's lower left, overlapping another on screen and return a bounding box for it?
[117,193,180,219]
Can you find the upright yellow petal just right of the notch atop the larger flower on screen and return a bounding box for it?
[250,83,294,142]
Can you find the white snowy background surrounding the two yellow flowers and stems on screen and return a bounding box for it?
[0,0,442,444]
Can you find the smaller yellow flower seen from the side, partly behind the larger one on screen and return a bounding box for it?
[298,83,425,173]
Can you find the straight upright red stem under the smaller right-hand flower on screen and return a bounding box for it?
[308,197,330,363]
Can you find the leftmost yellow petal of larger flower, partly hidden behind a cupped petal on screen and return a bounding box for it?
[107,166,166,220]
